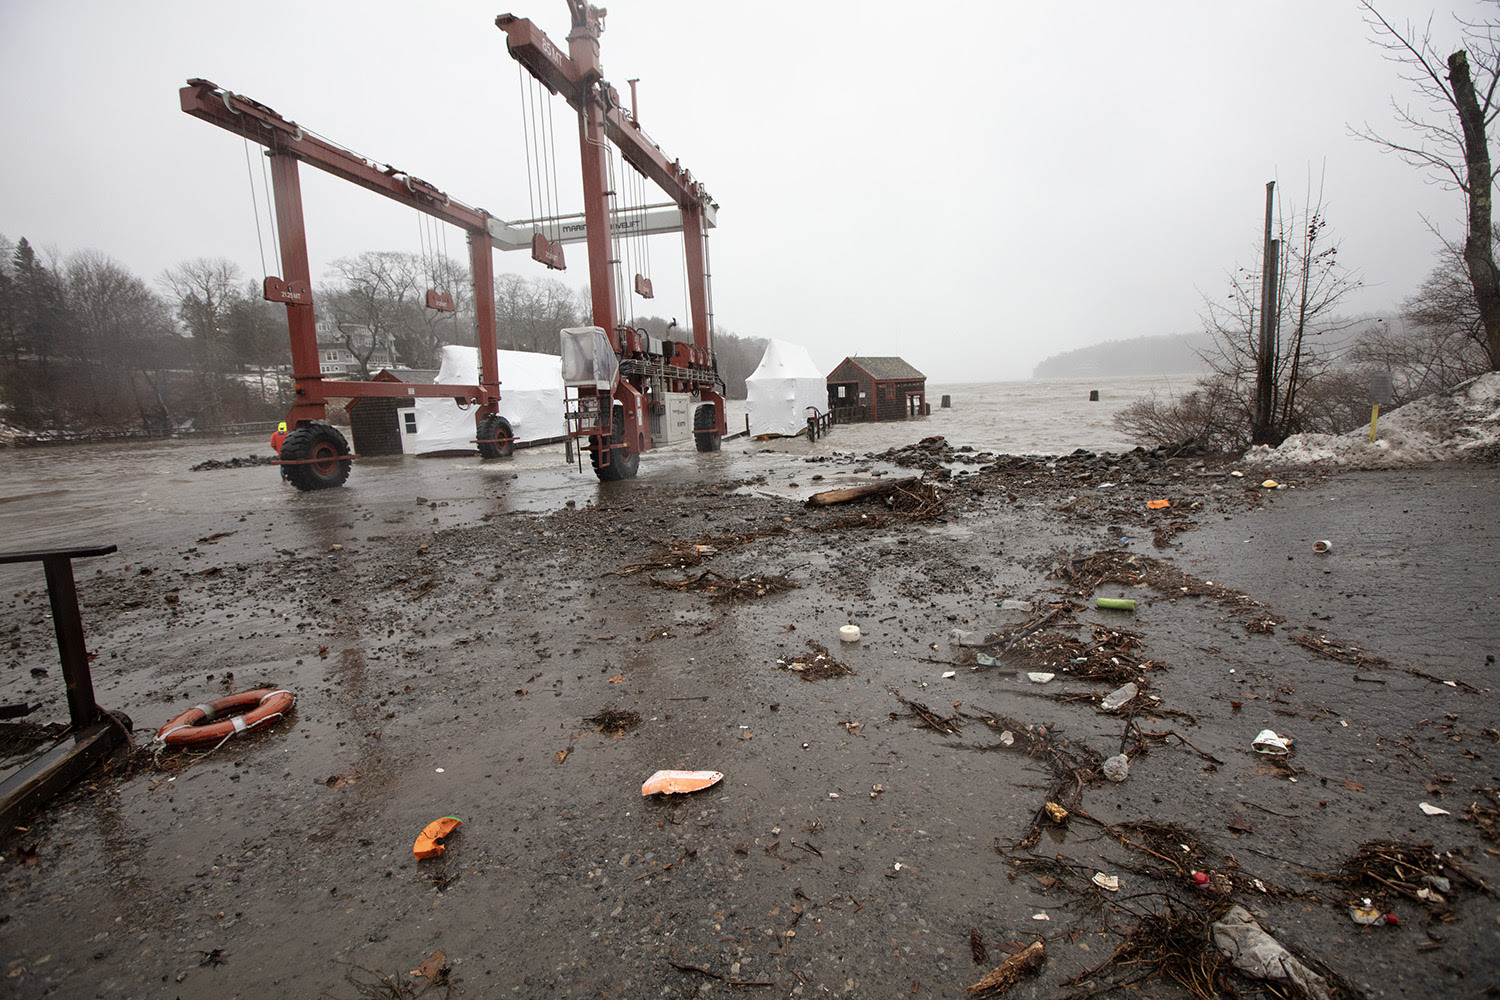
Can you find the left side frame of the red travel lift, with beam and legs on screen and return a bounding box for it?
[179,79,509,490]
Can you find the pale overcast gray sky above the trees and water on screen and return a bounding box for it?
[0,0,1496,381]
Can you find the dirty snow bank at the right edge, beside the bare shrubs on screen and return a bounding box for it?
[1245,372,1500,469]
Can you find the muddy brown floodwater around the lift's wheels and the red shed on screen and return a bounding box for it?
[0,376,1193,563]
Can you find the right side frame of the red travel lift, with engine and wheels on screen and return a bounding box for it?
[495,0,726,480]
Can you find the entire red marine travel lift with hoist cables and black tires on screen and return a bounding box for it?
[180,0,725,490]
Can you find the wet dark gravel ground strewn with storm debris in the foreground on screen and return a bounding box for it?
[0,441,1500,997]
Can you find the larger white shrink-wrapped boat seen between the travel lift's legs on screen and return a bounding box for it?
[414,346,567,454]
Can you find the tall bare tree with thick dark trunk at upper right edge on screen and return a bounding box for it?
[1350,0,1500,369]
